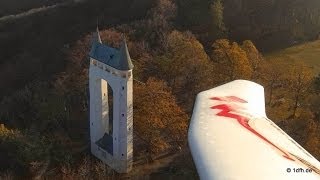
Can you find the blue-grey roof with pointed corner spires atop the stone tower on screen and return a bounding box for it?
[89,37,133,71]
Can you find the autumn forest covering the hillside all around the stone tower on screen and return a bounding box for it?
[0,0,320,179]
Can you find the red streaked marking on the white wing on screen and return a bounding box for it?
[211,96,294,161]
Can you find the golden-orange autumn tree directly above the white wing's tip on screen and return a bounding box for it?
[211,39,252,81]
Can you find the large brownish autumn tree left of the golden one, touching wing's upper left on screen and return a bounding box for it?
[154,31,219,111]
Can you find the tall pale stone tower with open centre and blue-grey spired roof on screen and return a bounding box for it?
[89,28,133,173]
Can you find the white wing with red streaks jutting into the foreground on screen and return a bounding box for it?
[188,80,320,180]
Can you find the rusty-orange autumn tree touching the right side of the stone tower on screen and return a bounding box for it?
[134,78,188,158]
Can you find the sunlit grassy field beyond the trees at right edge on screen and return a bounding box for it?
[265,40,320,74]
